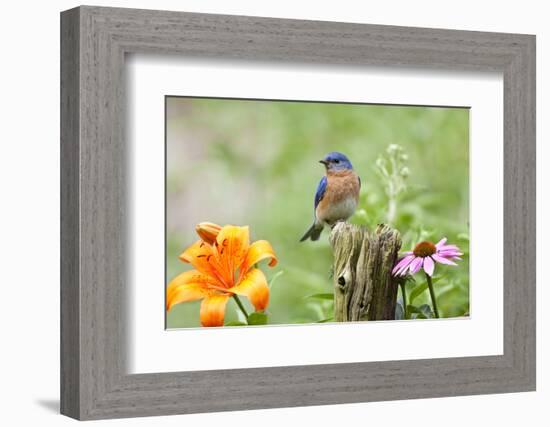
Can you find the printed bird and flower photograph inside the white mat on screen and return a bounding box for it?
[165,98,470,329]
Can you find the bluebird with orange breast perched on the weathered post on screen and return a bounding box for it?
[300,152,361,242]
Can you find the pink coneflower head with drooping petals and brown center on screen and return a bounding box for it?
[392,237,462,277]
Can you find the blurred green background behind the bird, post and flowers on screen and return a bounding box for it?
[166,97,469,328]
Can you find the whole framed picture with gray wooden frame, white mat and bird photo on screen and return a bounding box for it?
[61,6,535,420]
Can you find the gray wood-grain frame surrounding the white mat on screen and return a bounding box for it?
[61,6,536,419]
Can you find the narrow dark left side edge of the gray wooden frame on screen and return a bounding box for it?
[60,10,80,417]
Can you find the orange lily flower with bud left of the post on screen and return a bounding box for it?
[166,223,277,326]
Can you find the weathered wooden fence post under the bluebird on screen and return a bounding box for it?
[330,222,401,322]
